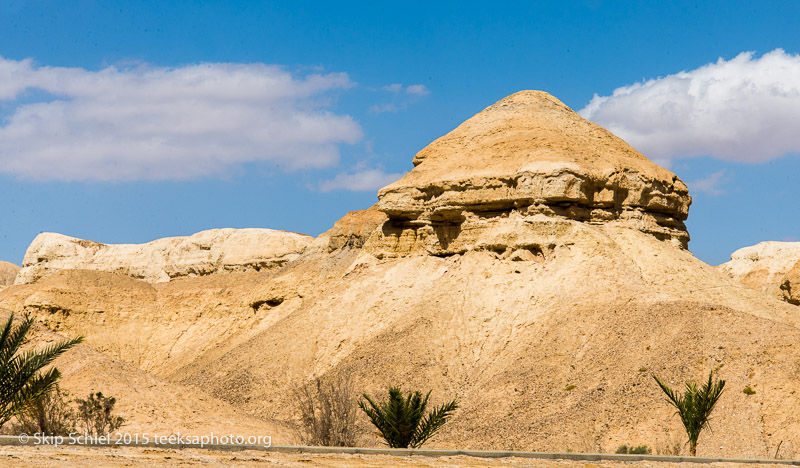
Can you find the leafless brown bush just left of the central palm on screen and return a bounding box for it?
[293,373,358,447]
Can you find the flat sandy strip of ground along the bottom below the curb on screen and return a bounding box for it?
[0,446,765,468]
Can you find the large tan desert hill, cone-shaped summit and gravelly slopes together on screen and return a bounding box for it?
[0,91,800,457]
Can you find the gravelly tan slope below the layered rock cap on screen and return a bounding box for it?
[0,221,800,456]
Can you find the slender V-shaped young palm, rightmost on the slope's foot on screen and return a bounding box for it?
[653,372,725,457]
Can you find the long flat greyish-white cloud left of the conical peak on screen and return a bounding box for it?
[0,57,362,181]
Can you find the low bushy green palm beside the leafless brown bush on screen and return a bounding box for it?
[358,387,458,448]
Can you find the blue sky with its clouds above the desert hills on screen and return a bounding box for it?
[0,0,800,264]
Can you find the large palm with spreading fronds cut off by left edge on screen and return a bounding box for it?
[0,314,83,426]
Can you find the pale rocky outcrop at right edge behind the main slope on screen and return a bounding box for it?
[719,242,800,305]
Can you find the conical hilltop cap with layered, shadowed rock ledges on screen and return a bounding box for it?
[368,91,691,255]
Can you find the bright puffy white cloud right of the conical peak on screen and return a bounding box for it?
[580,49,800,162]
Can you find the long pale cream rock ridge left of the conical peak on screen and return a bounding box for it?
[15,229,313,284]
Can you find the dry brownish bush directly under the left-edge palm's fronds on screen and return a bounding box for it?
[12,385,77,436]
